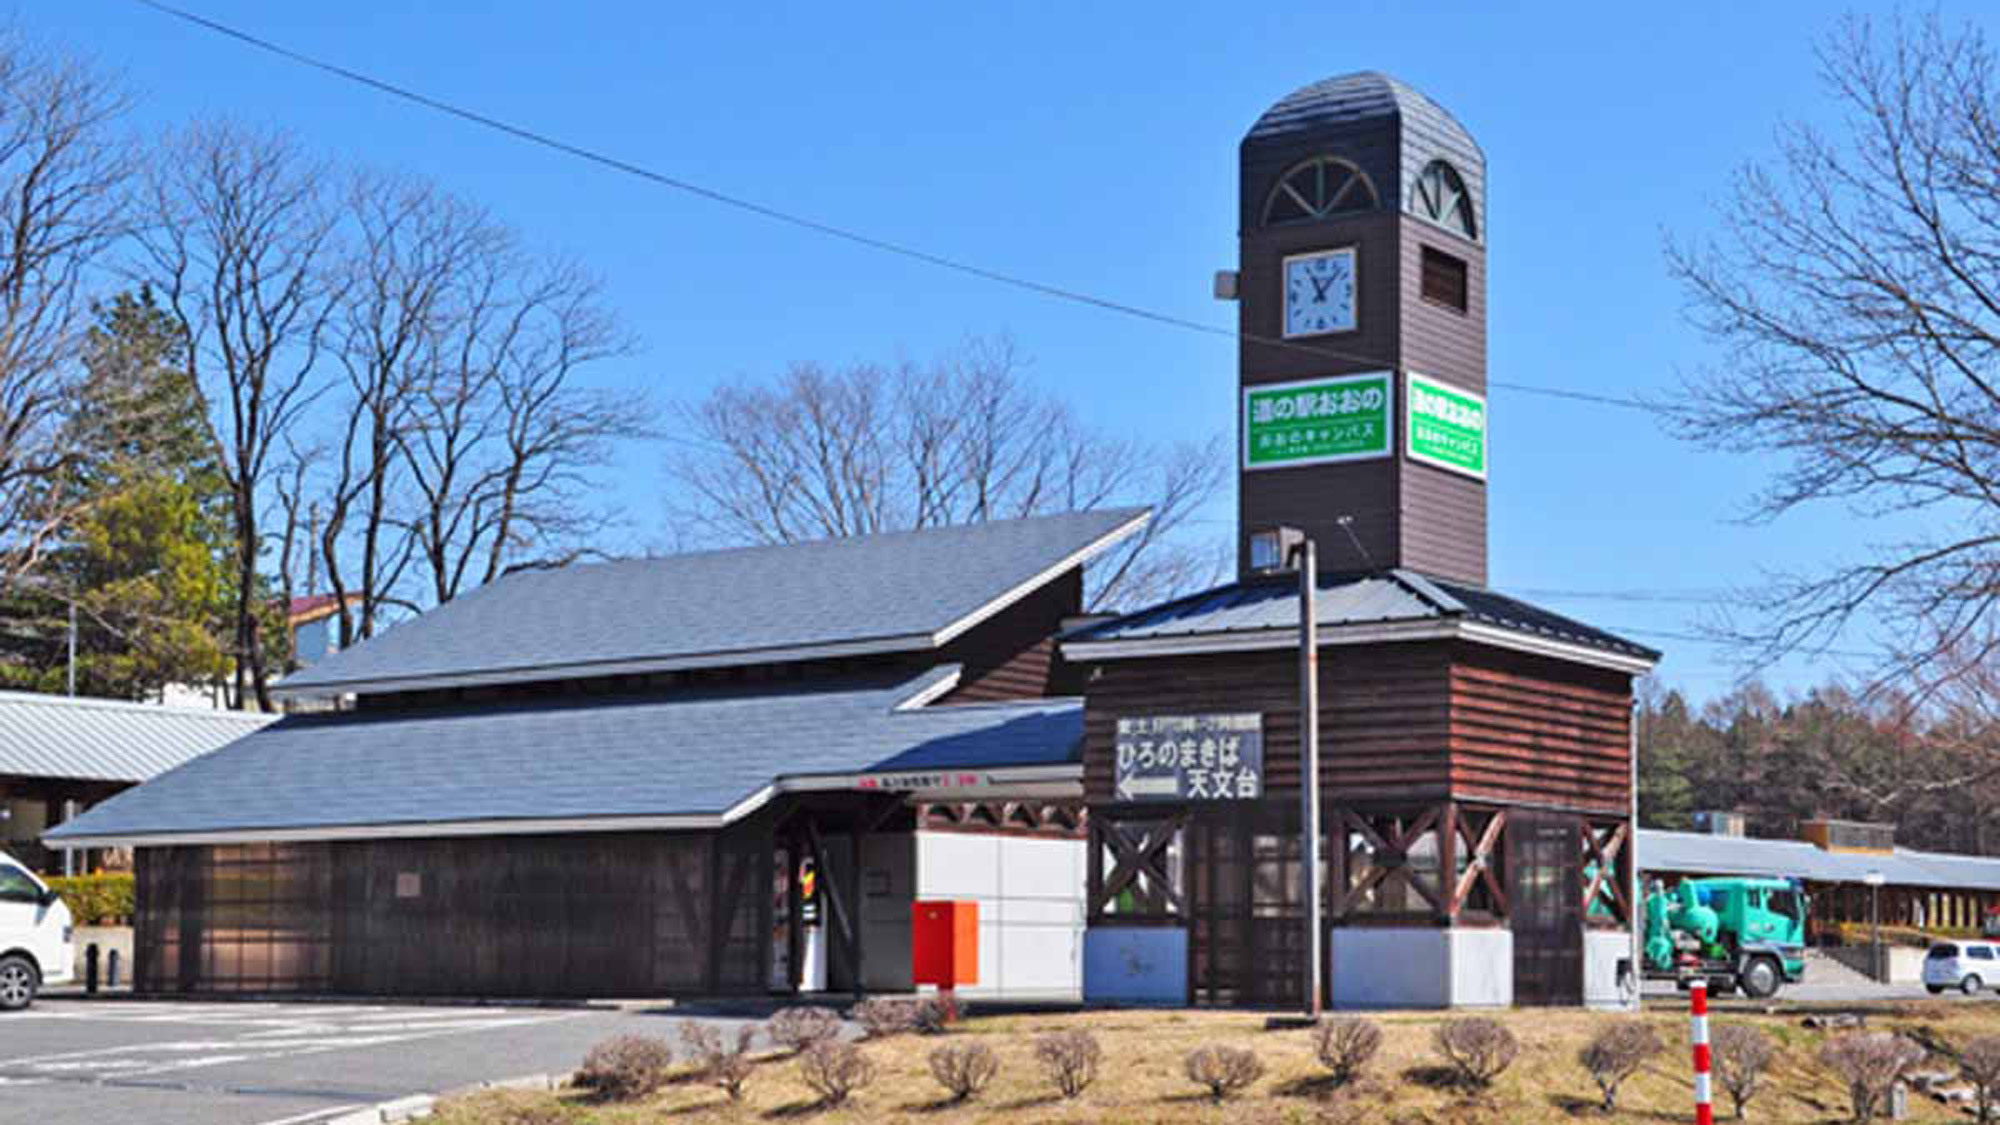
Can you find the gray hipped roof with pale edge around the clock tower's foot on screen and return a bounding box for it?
[1068,569,1660,661]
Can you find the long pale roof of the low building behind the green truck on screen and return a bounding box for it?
[1638,829,2000,891]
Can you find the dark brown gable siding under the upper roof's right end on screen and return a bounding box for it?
[938,567,1084,703]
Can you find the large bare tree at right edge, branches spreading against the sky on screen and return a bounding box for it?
[1670,16,2000,681]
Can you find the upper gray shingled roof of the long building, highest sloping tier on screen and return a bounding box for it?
[278,508,1148,697]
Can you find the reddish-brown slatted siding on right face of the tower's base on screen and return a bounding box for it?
[1450,645,1632,815]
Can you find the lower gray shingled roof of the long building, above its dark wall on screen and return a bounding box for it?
[46,667,1082,843]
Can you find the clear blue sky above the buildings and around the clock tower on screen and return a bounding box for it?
[35,0,1990,695]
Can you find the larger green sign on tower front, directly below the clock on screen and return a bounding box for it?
[1244,370,1396,468]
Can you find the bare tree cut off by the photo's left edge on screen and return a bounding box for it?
[0,32,136,587]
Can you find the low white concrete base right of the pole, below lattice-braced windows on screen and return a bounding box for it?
[1330,927,1514,1009]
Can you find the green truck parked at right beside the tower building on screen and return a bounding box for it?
[1646,879,1812,999]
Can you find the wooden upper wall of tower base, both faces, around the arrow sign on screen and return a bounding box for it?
[1084,641,1632,813]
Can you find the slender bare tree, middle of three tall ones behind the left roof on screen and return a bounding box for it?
[320,174,496,636]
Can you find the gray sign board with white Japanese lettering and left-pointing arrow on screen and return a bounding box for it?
[1114,713,1264,801]
